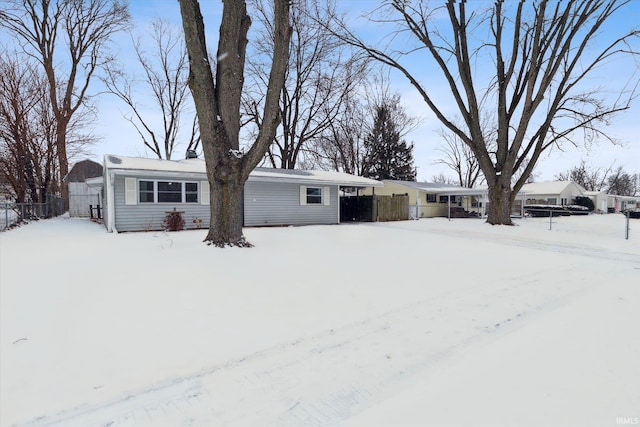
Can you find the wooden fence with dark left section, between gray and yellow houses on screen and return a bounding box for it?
[340,194,409,222]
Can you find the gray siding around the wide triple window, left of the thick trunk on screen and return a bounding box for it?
[114,175,209,232]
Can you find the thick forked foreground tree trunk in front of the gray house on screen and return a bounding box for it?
[179,0,291,247]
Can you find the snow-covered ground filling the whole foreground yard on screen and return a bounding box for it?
[0,214,640,427]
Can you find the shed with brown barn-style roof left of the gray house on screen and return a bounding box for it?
[63,160,103,217]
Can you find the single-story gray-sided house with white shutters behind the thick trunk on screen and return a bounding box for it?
[94,155,382,231]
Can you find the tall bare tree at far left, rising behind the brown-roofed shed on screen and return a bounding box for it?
[0,0,129,209]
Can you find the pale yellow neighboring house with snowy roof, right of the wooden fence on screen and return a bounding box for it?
[360,179,487,219]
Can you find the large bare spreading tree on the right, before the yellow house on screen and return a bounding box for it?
[330,0,640,224]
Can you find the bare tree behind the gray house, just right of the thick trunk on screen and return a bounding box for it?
[245,0,366,169]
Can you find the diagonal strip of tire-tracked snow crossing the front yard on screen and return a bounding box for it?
[18,269,588,427]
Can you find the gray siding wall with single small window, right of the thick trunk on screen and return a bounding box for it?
[244,180,340,226]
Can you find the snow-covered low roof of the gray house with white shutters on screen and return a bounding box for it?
[104,154,383,187]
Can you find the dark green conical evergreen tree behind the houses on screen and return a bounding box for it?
[362,105,416,181]
